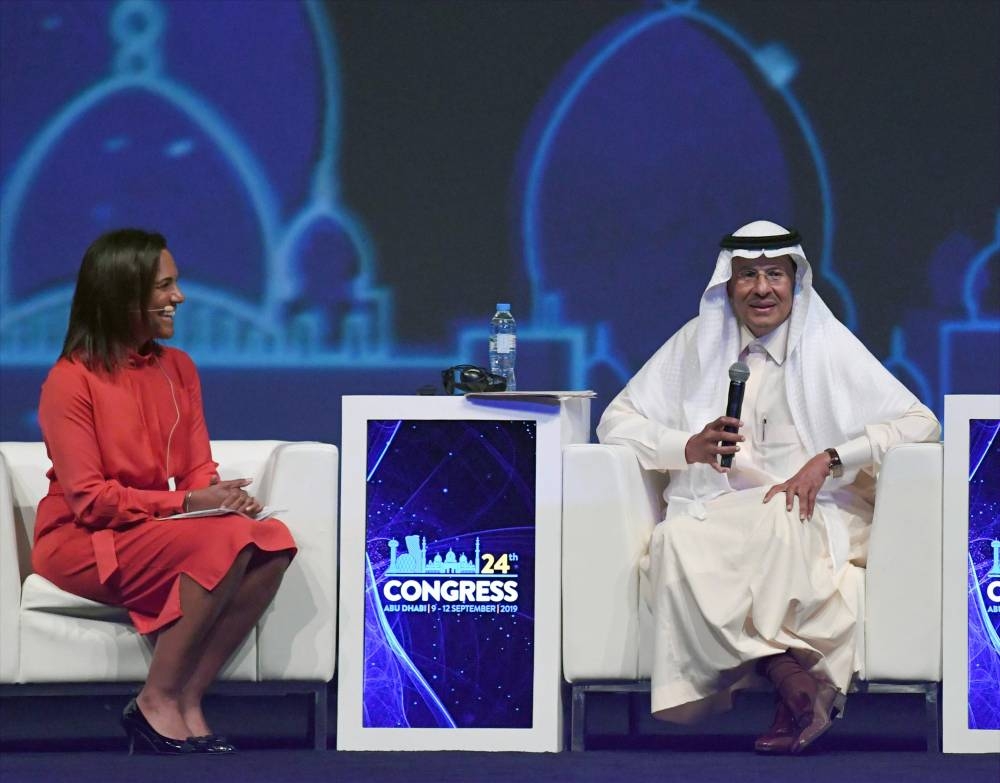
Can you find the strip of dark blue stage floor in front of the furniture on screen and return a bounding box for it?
[7,750,1000,783]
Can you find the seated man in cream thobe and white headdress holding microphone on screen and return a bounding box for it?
[597,221,940,753]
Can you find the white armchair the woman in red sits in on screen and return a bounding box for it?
[0,441,339,748]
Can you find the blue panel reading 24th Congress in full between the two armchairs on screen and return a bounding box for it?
[362,420,536,728]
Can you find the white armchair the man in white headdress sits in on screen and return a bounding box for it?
[562,443,942,750]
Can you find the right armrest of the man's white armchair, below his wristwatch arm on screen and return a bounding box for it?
[865,443,943,681]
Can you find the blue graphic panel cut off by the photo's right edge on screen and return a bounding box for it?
[969,419,1000,729]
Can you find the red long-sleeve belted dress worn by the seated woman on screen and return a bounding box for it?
[32,347,296,634]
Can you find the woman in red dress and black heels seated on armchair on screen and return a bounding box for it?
[32,229,296,753]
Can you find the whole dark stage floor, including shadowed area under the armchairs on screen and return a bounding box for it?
[0,693,1000,783]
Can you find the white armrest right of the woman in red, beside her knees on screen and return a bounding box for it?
[257,443,339,681]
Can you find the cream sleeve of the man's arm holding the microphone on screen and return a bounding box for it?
[597,386,691,470]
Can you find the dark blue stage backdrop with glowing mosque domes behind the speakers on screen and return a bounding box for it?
[0,0,1000,442]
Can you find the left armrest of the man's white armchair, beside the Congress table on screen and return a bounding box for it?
[562,444,664,682]
